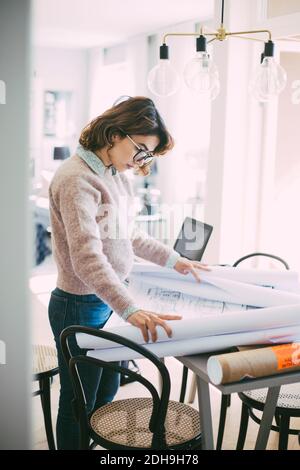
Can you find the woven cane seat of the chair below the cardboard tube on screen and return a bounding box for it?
[243,383,300,409]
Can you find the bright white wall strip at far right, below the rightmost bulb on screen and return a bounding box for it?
[264,51,300,271]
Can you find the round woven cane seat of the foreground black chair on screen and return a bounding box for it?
[90,398,200,448]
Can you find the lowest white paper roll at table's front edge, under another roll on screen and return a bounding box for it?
[87,327,300,362]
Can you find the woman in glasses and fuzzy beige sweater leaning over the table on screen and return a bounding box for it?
[49,97,206,449]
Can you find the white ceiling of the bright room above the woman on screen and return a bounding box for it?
[33,0,214,48]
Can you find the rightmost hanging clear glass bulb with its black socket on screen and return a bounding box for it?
[250,41,287,102]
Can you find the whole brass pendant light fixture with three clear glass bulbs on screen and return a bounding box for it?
[148,0,287,102]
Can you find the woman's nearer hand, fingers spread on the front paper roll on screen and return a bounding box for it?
[127,310,182,343]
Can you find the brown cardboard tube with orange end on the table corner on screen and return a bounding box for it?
[207,343,300,385]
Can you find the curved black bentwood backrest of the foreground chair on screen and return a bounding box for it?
[60,325,171,442]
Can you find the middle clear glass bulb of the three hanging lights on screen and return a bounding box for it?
[183,51,220,100]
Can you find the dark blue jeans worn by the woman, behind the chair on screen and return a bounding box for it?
[48,287,120,449]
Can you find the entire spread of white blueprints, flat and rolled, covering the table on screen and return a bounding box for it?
[76,265,300,361]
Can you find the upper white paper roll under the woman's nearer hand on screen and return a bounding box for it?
[76,304,300,349]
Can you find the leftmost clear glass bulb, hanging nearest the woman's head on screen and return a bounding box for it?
[148,59,180,96]
